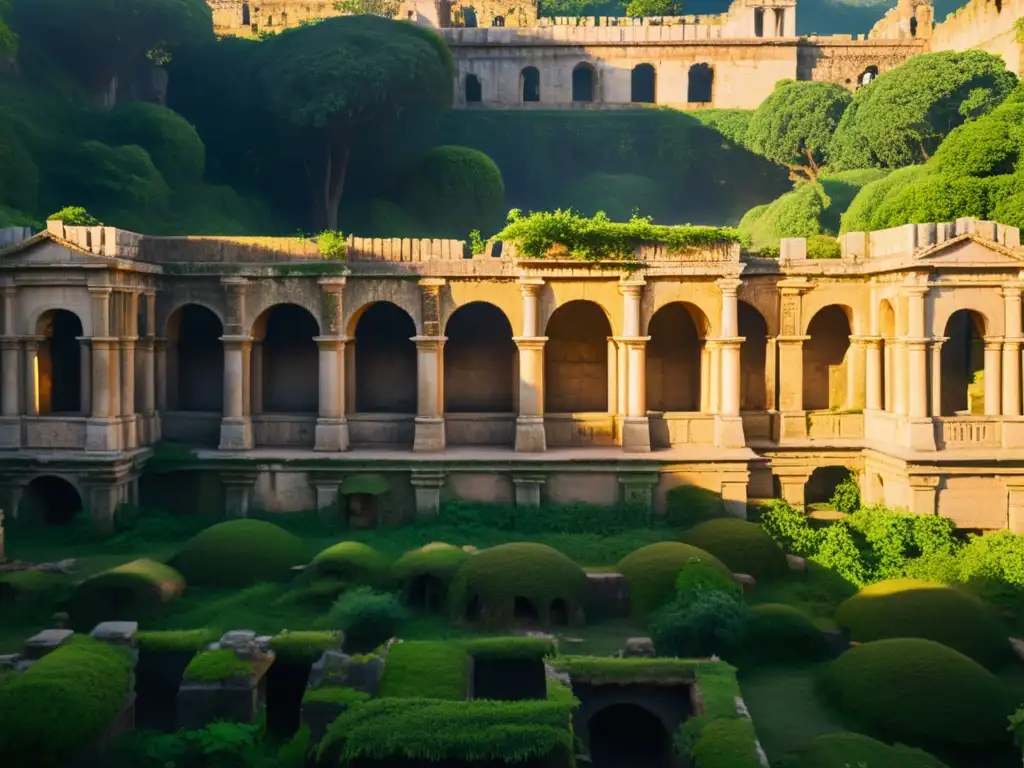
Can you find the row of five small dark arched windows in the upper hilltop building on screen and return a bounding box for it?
[463,61,715,104]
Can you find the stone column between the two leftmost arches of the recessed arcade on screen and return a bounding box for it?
[219,278,253,450]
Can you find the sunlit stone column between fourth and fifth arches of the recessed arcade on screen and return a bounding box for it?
[513,278,548,454]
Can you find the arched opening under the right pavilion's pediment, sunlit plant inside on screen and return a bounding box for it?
[941,309,985,416]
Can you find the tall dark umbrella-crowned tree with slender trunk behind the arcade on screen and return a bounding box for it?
[256,15,453,229]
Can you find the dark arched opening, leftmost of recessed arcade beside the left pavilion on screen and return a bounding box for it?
[167,304,224,413]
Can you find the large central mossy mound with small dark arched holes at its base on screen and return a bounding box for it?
[449,542,588,626]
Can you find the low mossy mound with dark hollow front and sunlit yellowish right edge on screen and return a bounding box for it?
[69,558,185,631]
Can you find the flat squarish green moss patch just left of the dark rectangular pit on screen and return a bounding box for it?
[378,641,469,700]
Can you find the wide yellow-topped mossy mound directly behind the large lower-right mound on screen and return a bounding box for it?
[836,579,1011,667]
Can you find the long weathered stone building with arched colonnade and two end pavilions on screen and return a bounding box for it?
[0,219,1024,531]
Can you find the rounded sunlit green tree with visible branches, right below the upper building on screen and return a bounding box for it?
[744,80,853,181]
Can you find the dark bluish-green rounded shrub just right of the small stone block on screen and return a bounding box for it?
[647,590,746,658]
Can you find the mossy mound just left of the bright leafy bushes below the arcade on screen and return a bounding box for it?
[682,517,788,579]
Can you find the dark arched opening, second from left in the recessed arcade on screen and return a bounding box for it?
[252,304,319,414]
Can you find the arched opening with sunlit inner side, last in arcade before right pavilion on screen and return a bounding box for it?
[804,304,852,411]
